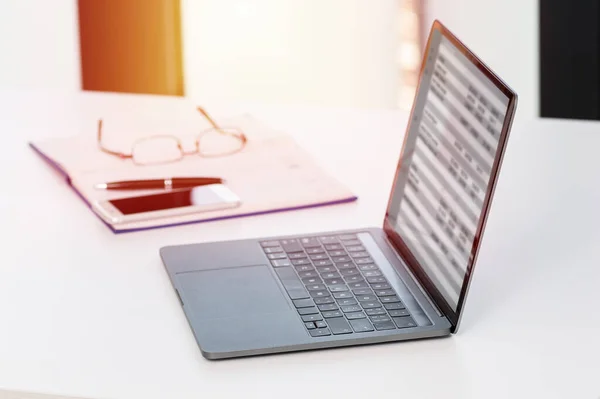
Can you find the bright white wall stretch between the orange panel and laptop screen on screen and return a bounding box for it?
[182,0,398,107]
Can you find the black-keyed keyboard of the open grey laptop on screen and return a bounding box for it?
[261,234,417,337]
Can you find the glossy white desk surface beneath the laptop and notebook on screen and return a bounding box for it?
[0,93,600,399]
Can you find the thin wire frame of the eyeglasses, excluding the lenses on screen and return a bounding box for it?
[97,106,248,165]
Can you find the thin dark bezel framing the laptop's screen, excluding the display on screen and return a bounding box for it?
[383,20,517,333]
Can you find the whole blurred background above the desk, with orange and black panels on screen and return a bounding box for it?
[0,0,580,119]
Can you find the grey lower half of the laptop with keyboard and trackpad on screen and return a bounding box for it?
[160,228,451,359]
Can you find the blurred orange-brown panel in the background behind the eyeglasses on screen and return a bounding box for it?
[78,0,184,96]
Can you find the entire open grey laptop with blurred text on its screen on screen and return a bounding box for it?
[160,21,517,359]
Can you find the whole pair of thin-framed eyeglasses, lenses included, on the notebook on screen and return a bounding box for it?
[98,107,248,165]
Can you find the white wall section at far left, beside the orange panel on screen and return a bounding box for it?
[0,0,81,91]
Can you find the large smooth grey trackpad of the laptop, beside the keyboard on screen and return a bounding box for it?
[177,265,290,320]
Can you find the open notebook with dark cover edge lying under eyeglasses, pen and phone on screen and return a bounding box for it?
[30,107,357,233]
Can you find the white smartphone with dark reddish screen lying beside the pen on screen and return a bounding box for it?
[92,184,241,224]
